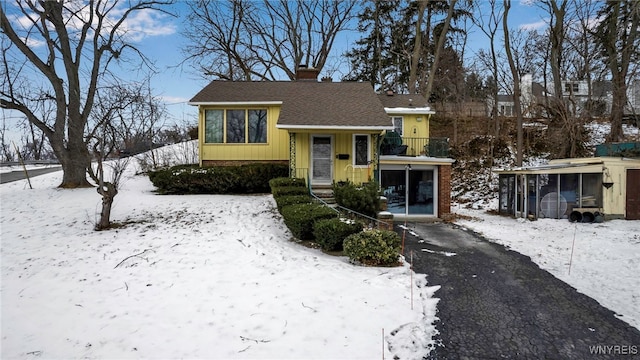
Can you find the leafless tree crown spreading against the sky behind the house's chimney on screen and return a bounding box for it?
[184,0,356,80]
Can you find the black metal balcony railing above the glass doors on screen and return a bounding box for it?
[380,137,449,158]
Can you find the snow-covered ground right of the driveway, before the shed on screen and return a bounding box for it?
[453,207,640,329]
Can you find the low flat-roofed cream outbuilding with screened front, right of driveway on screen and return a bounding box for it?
[496,157,640,220]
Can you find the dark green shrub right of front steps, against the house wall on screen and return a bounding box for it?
[333,181,380,217]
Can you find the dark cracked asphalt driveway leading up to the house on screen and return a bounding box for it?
[396,223,640,359]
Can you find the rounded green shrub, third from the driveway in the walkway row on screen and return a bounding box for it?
[280,204,338,240]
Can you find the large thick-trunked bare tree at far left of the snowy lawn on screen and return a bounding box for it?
[0,0,172,188]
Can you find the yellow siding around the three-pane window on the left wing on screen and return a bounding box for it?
[198,106,289,164]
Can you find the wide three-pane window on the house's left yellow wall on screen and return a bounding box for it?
[204,109,267,144]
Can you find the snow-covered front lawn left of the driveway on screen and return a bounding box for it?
[0,163,438,359]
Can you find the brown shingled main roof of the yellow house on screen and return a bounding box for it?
[190,81,392,129]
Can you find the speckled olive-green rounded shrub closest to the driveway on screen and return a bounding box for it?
[343,230,401,266]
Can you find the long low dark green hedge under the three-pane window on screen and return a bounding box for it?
[149,164,289,194]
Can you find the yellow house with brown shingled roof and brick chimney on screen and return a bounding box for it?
[189,67,453,217]
